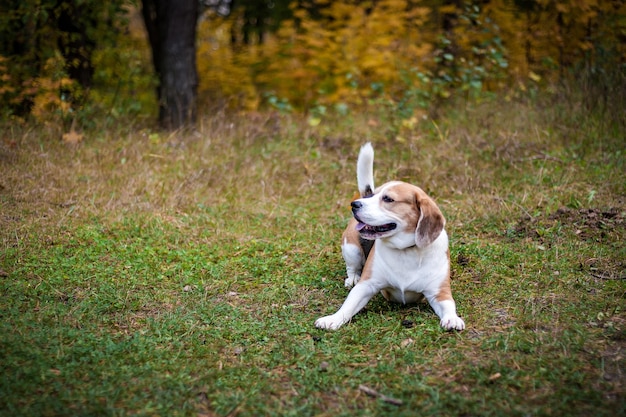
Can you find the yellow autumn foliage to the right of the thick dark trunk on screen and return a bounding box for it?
[198,0,626,109]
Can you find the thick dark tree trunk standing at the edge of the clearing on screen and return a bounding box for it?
[142,0,199,129]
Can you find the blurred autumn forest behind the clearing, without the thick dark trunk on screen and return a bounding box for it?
[0,0,626,130]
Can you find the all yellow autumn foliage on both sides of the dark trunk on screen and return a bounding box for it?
[6,0,626,121]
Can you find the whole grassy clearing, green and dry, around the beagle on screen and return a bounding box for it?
[0,95,626,416]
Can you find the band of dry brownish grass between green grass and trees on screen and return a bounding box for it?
[1,95,624,236]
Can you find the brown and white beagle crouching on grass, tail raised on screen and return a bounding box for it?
[315,143,465,330]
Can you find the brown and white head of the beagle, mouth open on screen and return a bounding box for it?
[352,181,446,249]
